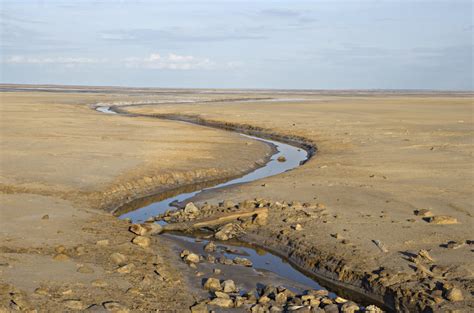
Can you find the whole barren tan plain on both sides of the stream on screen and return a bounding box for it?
[0,86,474,312]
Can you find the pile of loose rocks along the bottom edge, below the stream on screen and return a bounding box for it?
[191,277,383,313]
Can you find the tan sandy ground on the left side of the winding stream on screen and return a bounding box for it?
[0,92,271,312]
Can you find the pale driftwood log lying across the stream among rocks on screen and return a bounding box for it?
[163,208,268,231]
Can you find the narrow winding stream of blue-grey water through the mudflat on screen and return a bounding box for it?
[96,106,366,308]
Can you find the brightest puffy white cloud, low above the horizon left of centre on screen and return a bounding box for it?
[124,53,217,70]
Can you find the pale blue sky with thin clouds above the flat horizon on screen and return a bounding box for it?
[0,0,474,90]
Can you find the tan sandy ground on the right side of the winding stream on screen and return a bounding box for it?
[127,92,474,311]
